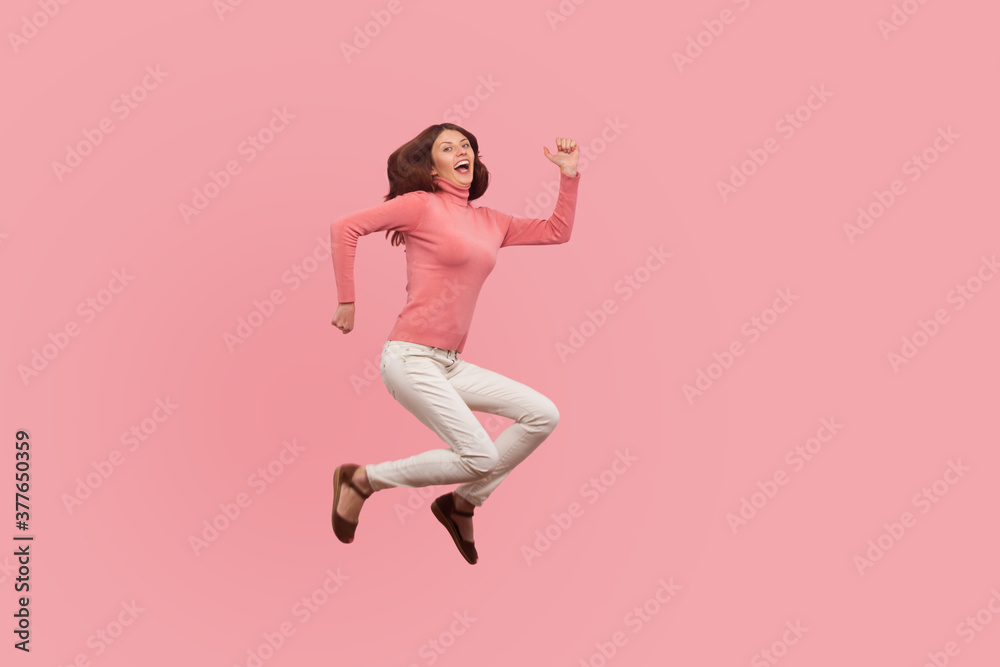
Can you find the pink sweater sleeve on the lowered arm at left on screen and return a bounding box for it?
[330,190,429,303]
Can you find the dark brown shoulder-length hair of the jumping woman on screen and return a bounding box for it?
[384,123,490,246]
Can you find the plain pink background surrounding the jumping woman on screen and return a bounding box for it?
[0,0,1000,667]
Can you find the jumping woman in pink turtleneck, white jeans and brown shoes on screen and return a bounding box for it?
[331,123,580,564]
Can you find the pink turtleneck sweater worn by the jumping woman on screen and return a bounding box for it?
[330,172,580,352]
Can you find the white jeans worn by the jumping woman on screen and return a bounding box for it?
[365,340,559,507]
